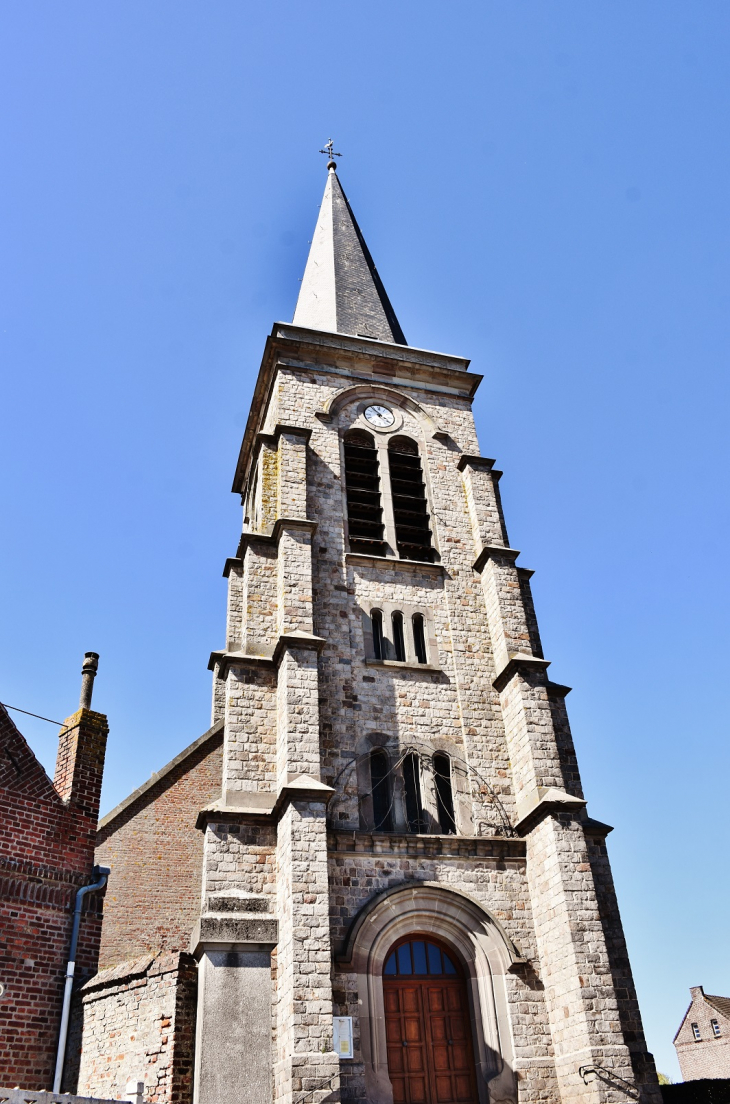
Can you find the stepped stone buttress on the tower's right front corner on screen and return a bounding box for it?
[464,458,649,1104]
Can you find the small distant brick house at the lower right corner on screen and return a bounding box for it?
[674,985,730,1081]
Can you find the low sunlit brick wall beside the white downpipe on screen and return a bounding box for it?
[65,952,197,1104]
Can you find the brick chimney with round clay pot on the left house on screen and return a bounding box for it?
[53,651,109,824]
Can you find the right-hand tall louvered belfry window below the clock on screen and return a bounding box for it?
[388,437,433,562]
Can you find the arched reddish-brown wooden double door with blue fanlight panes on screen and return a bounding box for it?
[383,935,478,1104]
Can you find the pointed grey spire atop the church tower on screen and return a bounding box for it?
[294,161,408,344]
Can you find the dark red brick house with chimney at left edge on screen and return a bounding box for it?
[0,652,108,1091]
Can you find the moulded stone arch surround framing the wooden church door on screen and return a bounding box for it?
[339,882,520,1104]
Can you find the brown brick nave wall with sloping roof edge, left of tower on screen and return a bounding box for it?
[96,728,223,968]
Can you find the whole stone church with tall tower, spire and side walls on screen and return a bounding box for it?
[75,162,660,1104]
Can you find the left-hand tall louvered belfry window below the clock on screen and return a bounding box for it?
[345,429,385,555]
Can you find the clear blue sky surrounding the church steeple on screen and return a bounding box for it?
[0,0,730,1076]
